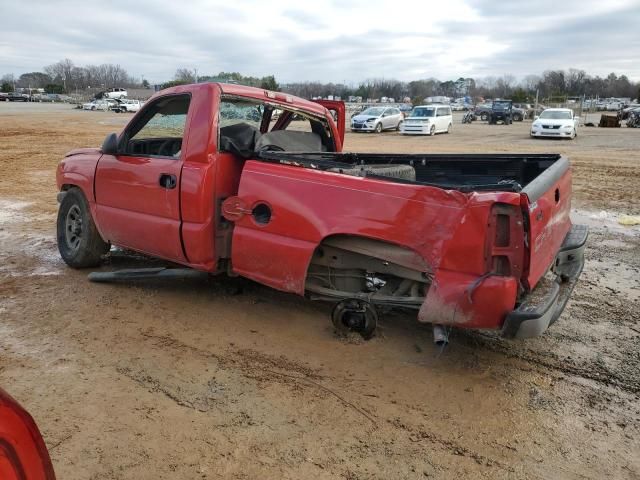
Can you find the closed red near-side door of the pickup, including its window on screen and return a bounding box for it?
[95,94,190,261]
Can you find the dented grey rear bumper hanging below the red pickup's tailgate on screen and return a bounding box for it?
[502,225,589,338]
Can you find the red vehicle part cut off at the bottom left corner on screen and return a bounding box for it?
[0,389,56,480]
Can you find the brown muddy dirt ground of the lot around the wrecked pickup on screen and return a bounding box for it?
[0,104,640,480]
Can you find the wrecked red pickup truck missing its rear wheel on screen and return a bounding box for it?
[57,83,587,341]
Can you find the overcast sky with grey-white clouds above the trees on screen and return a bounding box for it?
[0,0,640,83]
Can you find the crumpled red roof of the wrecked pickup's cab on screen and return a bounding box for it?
[154,82,326,116]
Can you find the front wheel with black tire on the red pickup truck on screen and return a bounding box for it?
[57,188,109,268]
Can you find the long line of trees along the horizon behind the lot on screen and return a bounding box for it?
[0,58,640,104]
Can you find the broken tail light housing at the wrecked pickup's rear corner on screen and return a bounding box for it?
[485,203,524,279]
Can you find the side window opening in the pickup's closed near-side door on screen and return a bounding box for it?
[120,95,191,159]
